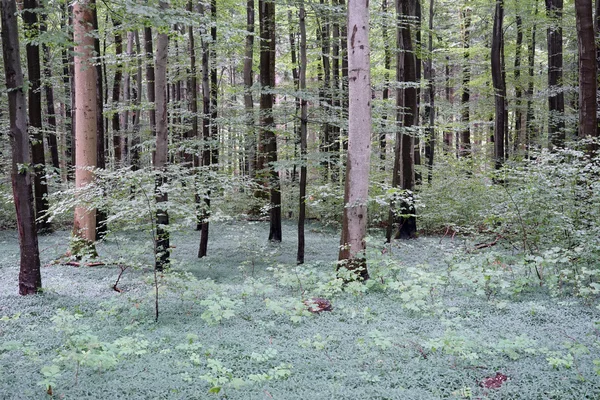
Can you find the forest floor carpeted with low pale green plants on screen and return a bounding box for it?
[0,221,600,400]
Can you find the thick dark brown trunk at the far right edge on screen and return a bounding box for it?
[575,0,598,138]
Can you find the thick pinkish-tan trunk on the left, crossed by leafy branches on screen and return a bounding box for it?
[71,0,98,256]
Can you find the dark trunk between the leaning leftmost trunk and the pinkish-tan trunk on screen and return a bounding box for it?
[23,0,51,232]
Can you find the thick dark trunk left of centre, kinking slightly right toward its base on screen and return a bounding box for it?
[258,0,282,242]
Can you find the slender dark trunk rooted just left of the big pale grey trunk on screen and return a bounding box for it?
[296,0,308,264]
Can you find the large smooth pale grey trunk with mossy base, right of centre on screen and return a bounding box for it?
[338,0,371,280]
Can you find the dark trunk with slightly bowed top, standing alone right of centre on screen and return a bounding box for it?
[491,0,507,169]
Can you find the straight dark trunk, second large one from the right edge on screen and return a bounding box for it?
[546,0,565,147]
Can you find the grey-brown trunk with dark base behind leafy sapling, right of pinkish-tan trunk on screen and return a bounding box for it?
[154,1,170,271]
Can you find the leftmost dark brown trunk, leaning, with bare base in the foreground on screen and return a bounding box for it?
[0,0,42,295]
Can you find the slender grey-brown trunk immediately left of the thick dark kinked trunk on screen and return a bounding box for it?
[244,0,256,178]
